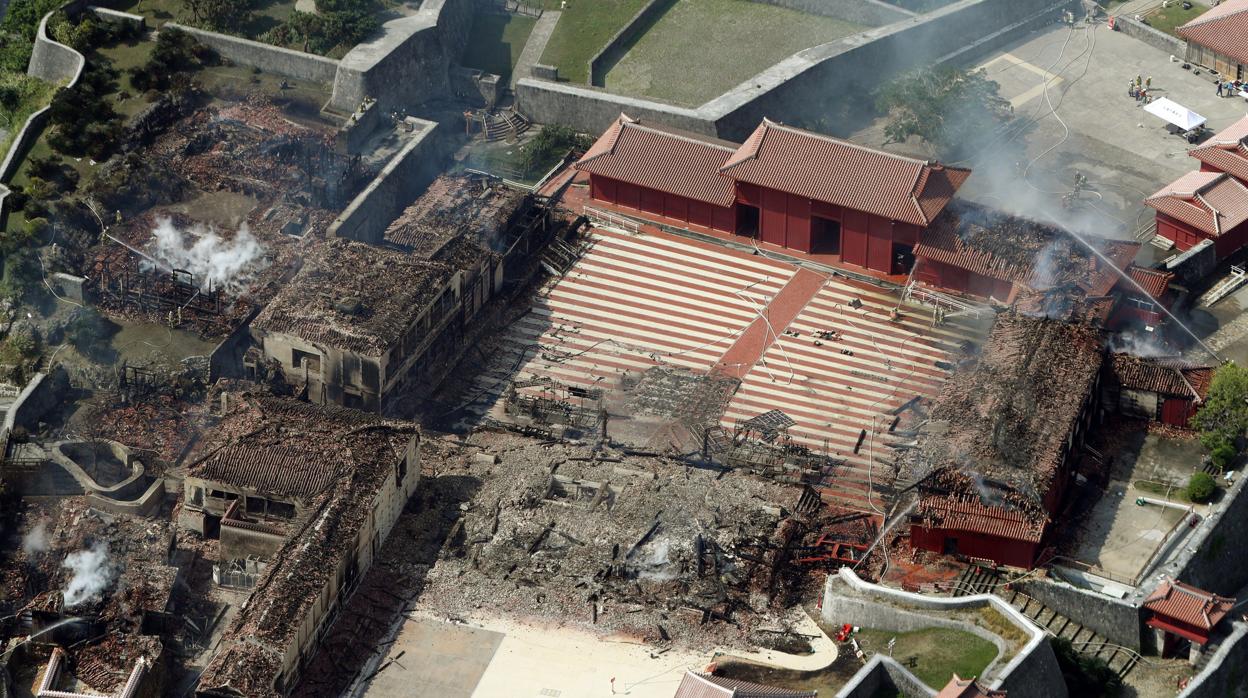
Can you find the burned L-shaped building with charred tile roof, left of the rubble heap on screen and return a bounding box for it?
[180,392,421,697]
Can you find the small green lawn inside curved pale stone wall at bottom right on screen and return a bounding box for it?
[854,628,997,691]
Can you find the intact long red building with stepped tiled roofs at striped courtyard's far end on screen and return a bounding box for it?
[575,115,971,275]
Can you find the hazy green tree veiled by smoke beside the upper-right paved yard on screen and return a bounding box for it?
[876,65,1013,159]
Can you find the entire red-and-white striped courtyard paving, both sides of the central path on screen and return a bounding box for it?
[464,229,980,507]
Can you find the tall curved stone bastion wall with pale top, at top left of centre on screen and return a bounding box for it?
[328,0,474,114]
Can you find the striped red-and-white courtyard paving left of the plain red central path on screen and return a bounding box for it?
[464,229,796,412]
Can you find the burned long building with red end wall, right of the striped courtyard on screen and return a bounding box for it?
[902,313,1104,568]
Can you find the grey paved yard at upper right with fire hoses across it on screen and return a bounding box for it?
[851,24,1248,248]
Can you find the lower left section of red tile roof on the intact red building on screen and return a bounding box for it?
[577,114,735,206]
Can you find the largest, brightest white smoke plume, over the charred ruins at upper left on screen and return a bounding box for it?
[150,219,268,293]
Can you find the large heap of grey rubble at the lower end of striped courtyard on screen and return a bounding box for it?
[419,432,816,647]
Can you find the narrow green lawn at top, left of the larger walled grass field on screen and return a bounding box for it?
[542,0,645,82]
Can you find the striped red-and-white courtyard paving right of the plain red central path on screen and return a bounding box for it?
[721,277,982,511]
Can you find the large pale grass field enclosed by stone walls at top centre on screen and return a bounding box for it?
[604,0,864,106]
